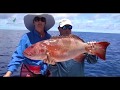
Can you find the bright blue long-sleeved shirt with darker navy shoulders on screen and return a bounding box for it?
[8,30,51,75]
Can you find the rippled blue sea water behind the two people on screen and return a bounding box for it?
[0,30,120,77]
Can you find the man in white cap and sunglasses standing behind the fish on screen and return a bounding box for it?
[49,19,98,77]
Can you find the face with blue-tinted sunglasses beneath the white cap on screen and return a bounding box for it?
[58,25,72,36]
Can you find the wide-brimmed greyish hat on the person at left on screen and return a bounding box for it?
[24,14,55,31]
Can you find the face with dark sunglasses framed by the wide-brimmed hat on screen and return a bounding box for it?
[33,17,46,32]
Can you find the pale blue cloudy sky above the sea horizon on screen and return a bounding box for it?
[0,13,120,34]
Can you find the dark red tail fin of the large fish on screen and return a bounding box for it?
[85,42,110,60]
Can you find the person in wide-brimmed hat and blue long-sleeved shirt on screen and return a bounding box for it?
[3,14,55,77]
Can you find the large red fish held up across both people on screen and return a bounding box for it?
[24,35,110,62]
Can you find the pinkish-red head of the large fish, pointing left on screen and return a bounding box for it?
[23,43,47,60]
